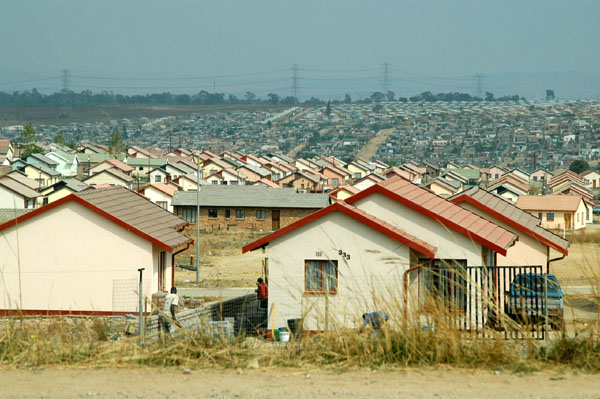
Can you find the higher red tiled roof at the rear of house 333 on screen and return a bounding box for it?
[346,177,518,256]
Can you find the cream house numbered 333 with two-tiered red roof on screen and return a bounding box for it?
[243,178,517,331]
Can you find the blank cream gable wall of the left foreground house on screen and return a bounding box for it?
[0,201,166,312]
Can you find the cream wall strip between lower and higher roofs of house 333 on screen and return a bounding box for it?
[354,193,485,266]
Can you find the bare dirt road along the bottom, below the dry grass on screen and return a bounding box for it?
[0,369,600,399]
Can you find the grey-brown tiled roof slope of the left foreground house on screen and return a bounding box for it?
[75,186,192,248]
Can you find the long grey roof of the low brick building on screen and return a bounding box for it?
[172,185,329,209]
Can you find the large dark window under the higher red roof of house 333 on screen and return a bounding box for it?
[419,259,467,311]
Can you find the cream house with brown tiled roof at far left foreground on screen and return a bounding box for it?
[0,187,193,315]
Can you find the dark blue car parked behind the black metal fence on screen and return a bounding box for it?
[504,273,565,328]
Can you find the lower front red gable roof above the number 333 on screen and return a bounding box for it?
[242,201,436,258]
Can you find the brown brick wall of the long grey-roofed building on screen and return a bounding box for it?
[174,206,318,231]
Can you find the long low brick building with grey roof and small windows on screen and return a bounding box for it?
[172,185,329,230]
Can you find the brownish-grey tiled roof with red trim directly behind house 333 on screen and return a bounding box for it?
[449,186,569,251]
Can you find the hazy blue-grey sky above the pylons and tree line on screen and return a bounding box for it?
[0,0,600,97]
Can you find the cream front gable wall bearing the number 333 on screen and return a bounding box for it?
[268,212,410,331]
